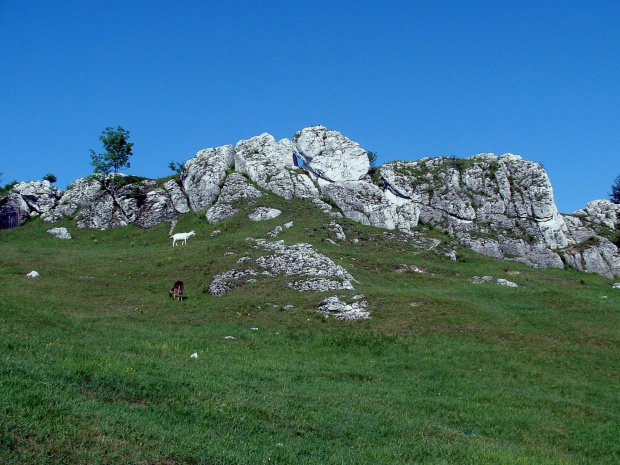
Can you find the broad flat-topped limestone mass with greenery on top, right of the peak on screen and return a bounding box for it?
[381,154,570,268]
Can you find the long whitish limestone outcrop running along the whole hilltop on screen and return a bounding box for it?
[0,126,620,280]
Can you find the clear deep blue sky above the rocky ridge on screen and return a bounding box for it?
[0,0,620,213]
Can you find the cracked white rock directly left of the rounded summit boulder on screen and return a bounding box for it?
[235,133,319,199]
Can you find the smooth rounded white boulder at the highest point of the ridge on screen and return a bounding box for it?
[293,126,370,182]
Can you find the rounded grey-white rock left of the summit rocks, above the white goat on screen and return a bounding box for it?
[181,145,235,211]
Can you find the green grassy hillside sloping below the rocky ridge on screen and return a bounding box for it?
[0,190,620,464]
